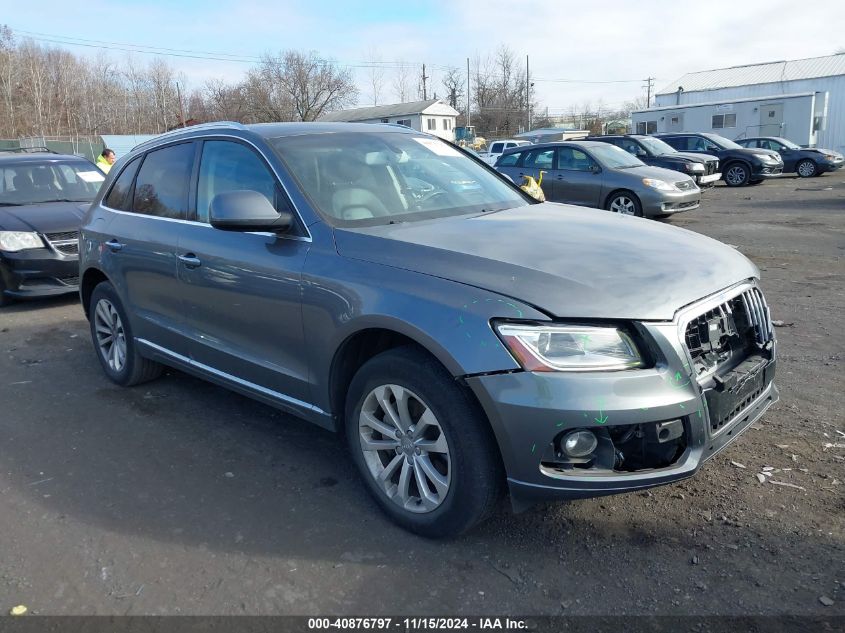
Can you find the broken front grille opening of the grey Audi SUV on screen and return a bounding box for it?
[684,288,773,378]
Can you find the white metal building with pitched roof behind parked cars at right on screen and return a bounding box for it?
[632,54,845,151]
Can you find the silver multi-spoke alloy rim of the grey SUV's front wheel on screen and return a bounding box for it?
[358,385,452,513]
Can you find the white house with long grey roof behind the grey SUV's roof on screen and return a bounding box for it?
[320,99,459,141]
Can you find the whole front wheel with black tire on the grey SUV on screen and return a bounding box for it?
[345,346,504,538]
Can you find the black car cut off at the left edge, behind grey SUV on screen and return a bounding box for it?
[0,149,104,306]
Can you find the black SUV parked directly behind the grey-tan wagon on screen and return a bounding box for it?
[585,134,722,187]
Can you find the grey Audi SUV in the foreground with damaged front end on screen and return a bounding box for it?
[80,123,777,536]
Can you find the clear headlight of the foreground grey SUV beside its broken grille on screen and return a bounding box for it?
[495,322,644,371]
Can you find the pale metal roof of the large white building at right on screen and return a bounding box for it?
[657,54,845,95]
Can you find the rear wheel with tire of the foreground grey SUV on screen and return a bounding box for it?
[88,281,164,387]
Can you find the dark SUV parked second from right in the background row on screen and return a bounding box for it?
[655,132,783,187]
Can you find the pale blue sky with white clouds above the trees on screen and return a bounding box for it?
[6,0,845,114]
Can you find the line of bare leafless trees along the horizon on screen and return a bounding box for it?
[0,25,632,138]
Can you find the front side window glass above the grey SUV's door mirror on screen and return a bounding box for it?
[197,141,276,222]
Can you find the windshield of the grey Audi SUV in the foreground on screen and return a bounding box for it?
[271,131,531,226]
